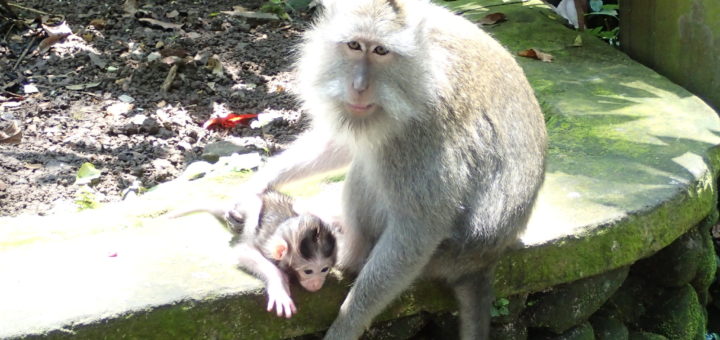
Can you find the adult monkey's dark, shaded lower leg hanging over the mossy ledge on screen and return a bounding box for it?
[453,270,493,340]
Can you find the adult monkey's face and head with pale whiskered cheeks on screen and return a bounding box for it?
[297,0,436,140]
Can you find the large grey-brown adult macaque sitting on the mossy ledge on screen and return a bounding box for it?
[236,0,546,339]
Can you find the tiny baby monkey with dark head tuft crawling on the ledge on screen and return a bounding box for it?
[226,190,337,318]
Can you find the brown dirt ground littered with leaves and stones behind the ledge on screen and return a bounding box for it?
[0,0,312,216]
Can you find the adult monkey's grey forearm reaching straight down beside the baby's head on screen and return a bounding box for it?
[325,214,446,340]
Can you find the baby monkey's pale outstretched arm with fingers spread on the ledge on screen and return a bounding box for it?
[236,244,297,318]
